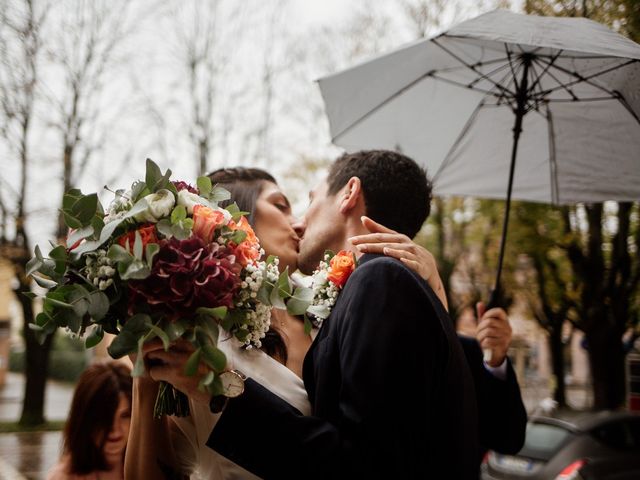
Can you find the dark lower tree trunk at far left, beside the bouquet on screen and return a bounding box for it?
[15,282,53,426]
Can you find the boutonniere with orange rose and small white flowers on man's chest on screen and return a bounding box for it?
[307,250,358,327]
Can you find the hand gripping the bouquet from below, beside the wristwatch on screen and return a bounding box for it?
[145,340,211,405]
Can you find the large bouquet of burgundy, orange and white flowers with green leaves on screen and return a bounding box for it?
[27,160,302,416]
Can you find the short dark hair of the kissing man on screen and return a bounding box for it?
[327,150,431,238]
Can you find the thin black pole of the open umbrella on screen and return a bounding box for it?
[488,53,532,362]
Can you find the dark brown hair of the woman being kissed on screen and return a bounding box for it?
[208,167,287,363]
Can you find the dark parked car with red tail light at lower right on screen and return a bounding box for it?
[481,412,640,480]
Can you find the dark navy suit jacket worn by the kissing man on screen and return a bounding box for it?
[207,255,478,479]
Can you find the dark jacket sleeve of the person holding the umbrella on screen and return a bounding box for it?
[458,335,527,464]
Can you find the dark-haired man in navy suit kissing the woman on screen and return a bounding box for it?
[208,151,478,479]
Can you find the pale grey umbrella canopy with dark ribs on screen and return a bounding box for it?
[319,10,640,204]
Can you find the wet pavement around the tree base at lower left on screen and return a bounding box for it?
[0,373,73,480]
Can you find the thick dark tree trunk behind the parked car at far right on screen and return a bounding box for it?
[587,326,625,410]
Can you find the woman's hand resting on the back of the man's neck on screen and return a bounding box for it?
[349,216,449,310]
